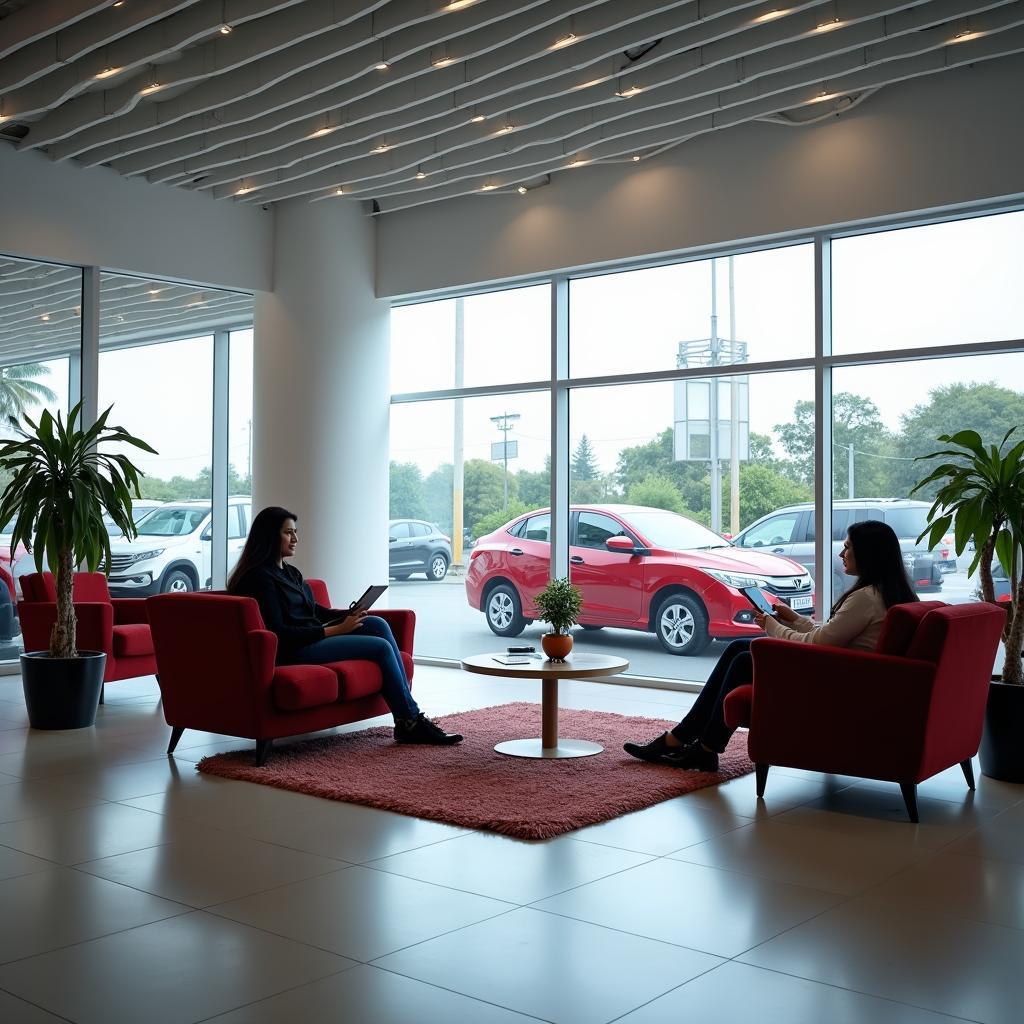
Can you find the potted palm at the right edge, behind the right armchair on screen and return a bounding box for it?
[911,427,1024,782]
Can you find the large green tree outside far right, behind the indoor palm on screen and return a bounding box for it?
[891,381,1024,501]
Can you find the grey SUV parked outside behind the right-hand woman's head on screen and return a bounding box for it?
[733,498,937,597]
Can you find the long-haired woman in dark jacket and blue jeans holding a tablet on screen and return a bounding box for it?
[227,506,462,745]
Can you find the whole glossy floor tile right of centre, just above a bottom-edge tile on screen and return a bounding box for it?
[535,859,841,956]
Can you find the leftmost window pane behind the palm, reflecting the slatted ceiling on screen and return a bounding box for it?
[0,251,82,663]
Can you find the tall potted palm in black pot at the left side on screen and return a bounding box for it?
[0,402,157,729]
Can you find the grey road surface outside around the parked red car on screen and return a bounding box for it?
[388,570,1001,682]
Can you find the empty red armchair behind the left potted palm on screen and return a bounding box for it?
[18,572,157,700]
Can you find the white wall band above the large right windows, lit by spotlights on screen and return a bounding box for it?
[377,56,1024,296]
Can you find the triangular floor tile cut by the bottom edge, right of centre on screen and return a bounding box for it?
[615,963,959,1024]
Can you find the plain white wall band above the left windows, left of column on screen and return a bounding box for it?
[0,143,273,289]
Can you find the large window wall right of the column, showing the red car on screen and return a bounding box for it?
[389,204,1024,681]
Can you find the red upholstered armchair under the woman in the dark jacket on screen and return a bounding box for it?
[146,580,416,765]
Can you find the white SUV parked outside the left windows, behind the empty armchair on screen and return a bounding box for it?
[108,495,252,597]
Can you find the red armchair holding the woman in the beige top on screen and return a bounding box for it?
[724,601,1006,821]
